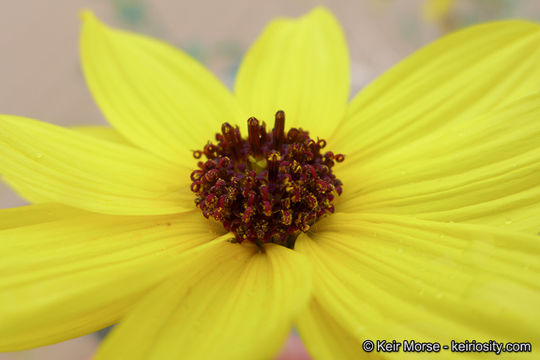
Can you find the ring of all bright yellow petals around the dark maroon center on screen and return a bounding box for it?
[0,5,540,360]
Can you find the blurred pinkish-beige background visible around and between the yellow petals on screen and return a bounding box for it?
[0,0,540,360]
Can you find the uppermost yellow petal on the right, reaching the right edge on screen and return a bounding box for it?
[327,21,540,161]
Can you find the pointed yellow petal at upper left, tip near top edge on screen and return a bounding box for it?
[81,12,243,165]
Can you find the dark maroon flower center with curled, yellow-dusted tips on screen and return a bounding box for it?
[191,111,345,249]
